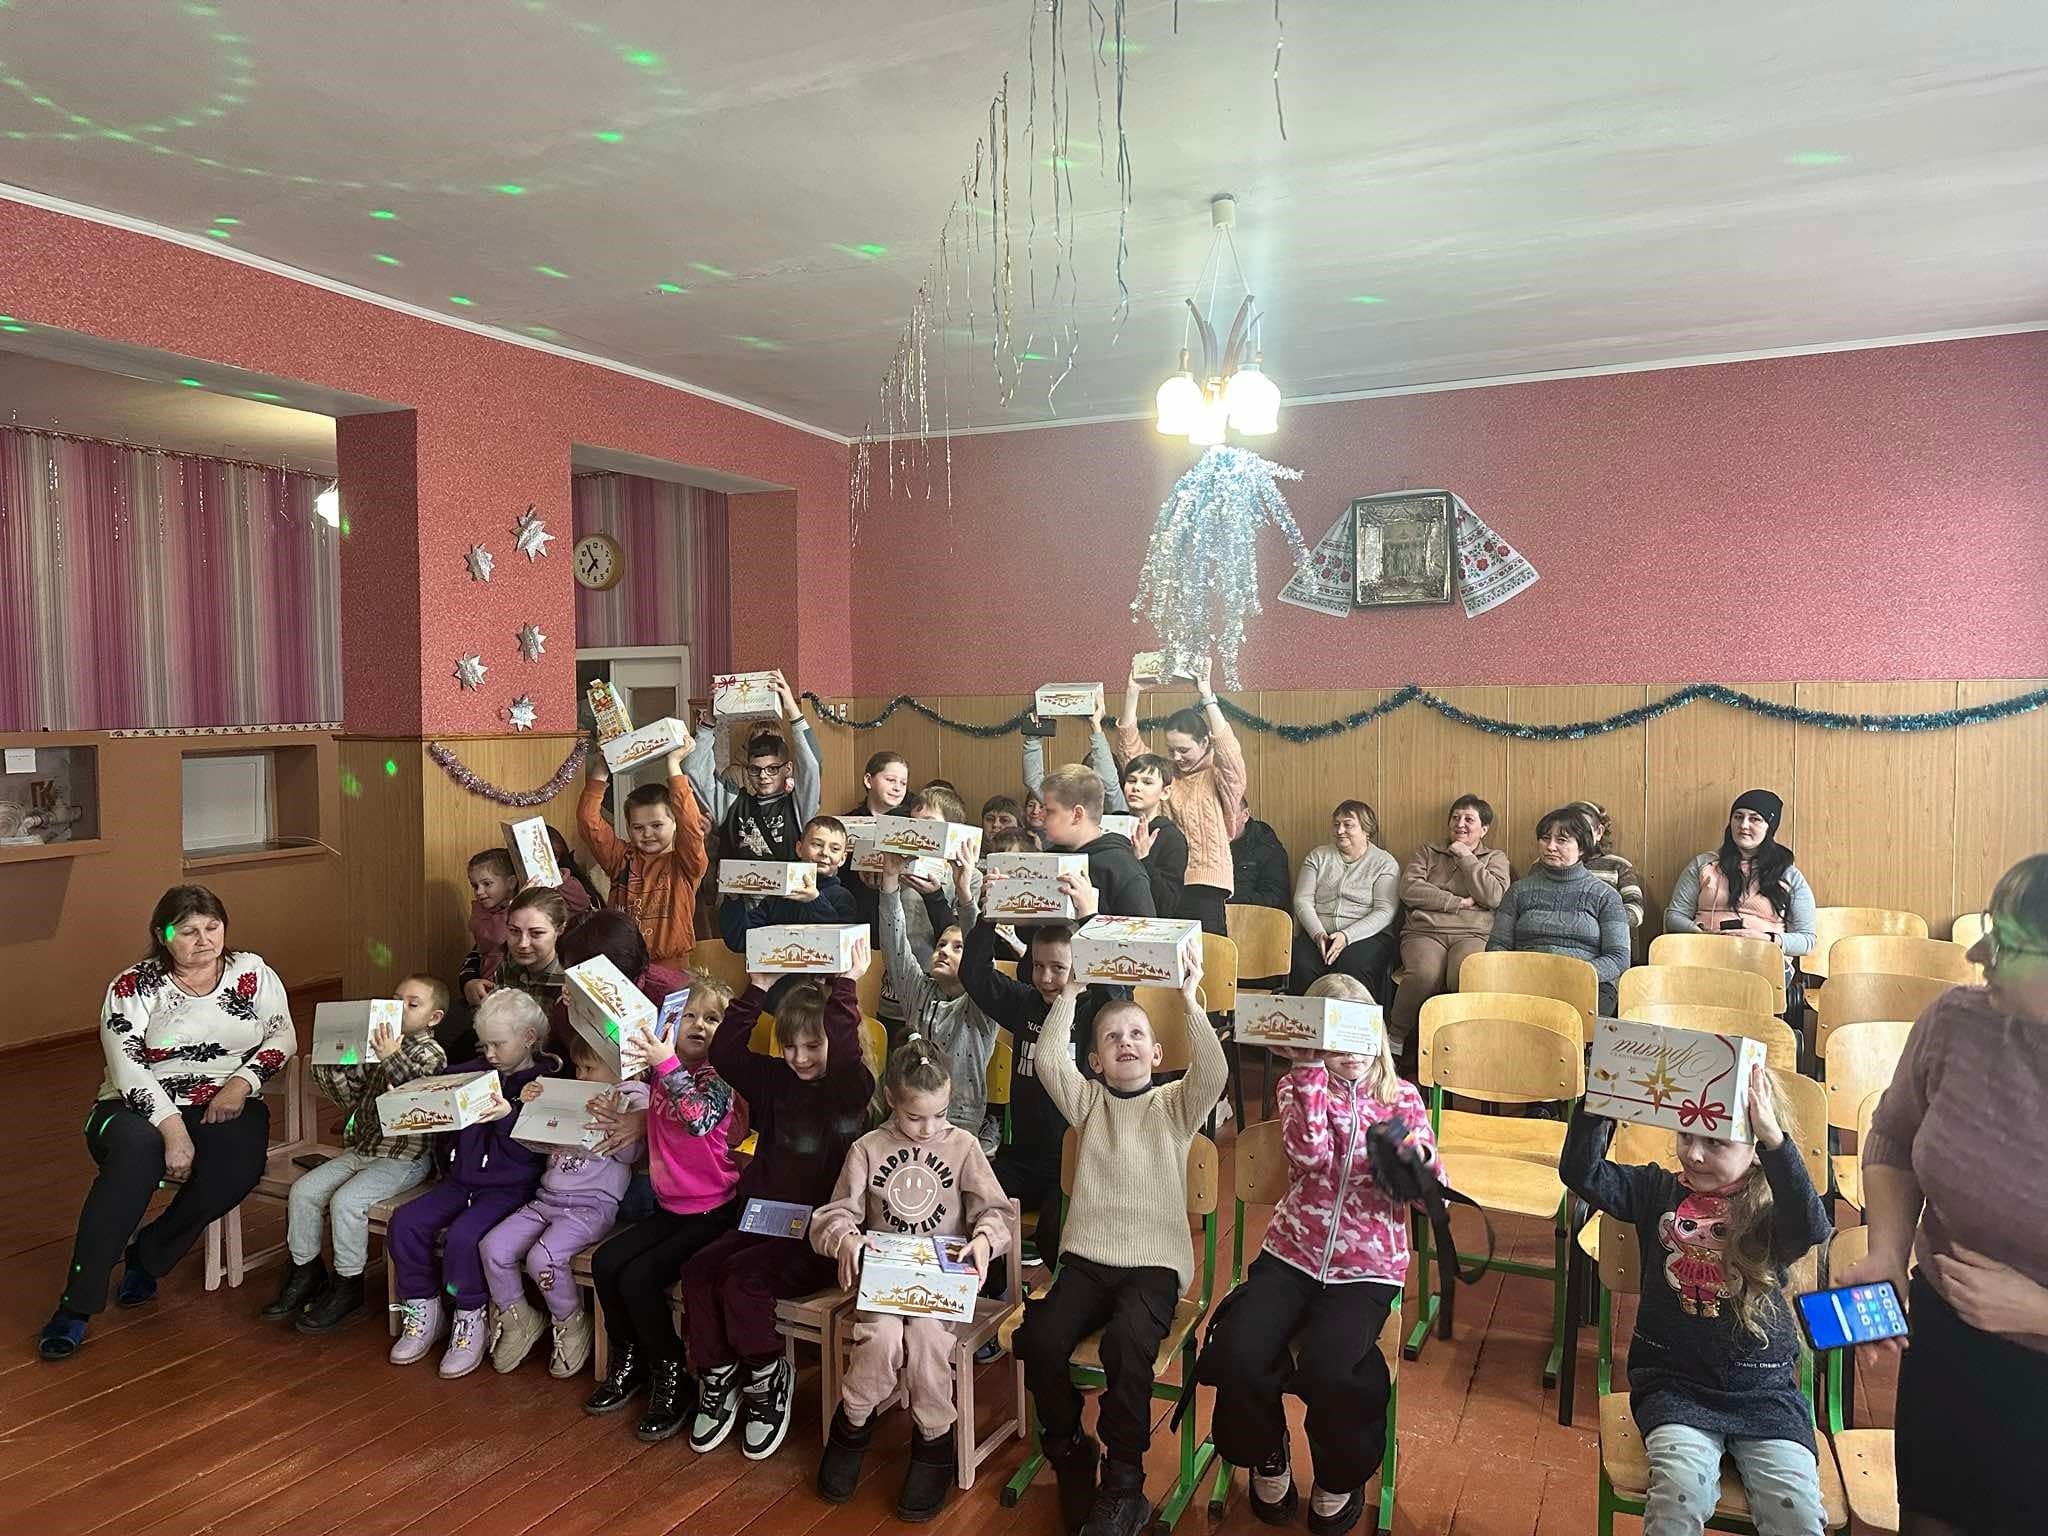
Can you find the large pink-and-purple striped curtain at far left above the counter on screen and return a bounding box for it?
[0,428,342,731]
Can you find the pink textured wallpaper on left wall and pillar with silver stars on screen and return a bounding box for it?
[0,201,852,735]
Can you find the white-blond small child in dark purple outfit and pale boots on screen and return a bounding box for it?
[385,999,561,1376]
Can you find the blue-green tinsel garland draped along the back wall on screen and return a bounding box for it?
[803,682,2048,741]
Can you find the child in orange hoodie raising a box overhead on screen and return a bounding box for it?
[575,748,707,967]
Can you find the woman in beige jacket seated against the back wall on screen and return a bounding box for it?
[1386,795,1513,1051]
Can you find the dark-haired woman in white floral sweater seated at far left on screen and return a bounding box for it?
[39,885,297,1360]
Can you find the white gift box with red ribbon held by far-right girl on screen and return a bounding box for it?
[1585,1018,1765,1141]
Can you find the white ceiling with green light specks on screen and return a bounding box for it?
[0,0,2048,432]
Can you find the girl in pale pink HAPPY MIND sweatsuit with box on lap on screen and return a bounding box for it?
[811,1040,1010,1522]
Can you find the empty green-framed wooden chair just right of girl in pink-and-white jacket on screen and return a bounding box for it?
[1403,991,1585,1386]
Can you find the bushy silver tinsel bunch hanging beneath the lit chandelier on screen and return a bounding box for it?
[1130,446,1309,688]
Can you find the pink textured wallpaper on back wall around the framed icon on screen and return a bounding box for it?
[854,334,2048,694]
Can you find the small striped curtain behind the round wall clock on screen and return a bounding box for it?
[571,473,733,696]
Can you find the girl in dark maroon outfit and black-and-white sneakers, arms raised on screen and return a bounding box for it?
[682,975,874,1460]
